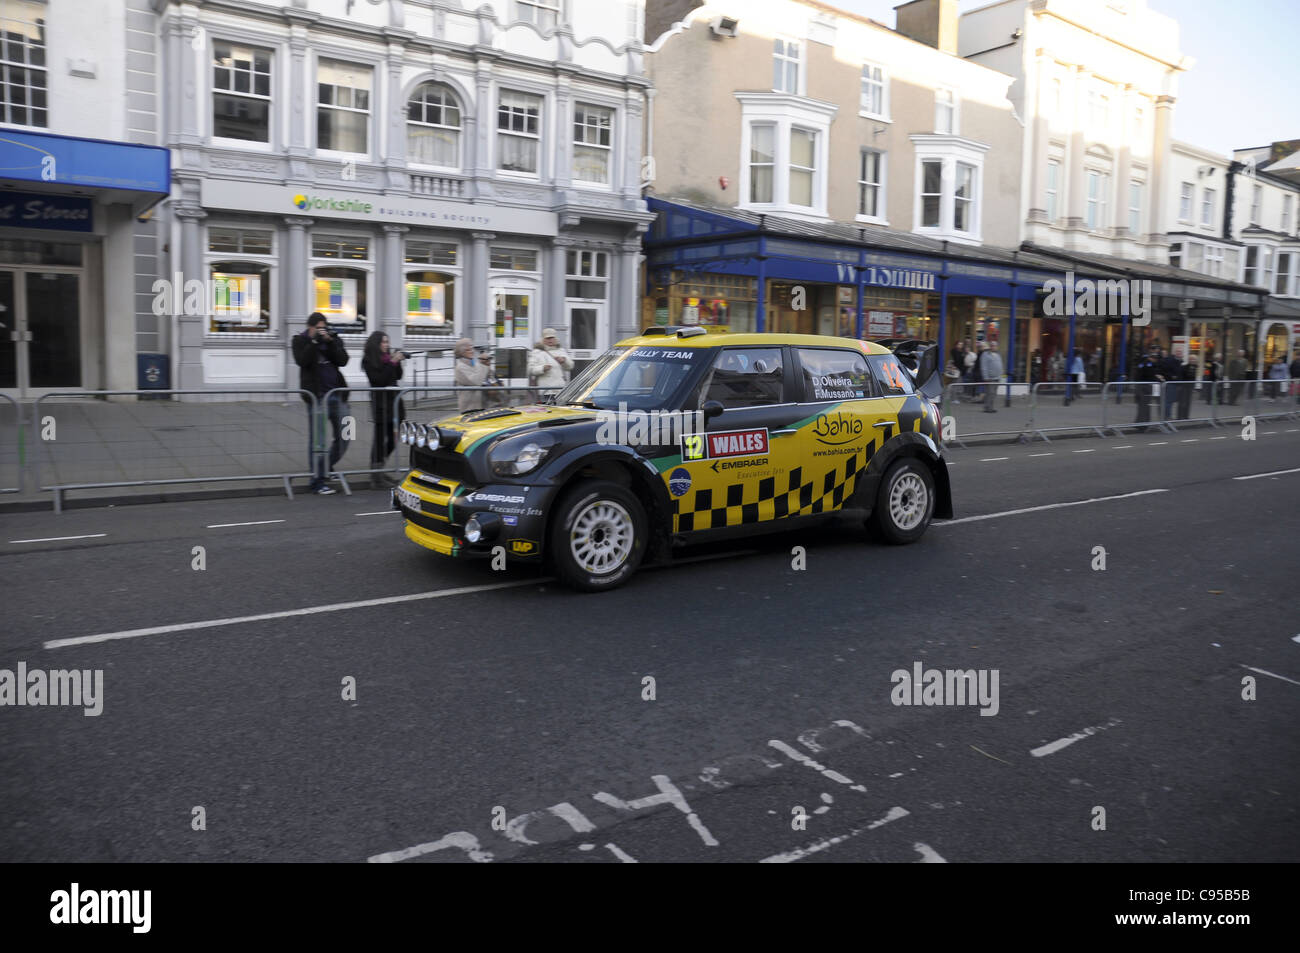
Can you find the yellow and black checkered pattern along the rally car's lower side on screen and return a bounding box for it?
[673,441,876,533]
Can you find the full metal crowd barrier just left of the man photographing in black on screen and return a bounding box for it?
[30,389,317,512]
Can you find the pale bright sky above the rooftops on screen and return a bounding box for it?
[828,0,1300,155]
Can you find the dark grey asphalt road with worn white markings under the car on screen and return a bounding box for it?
[0,421,1300,862]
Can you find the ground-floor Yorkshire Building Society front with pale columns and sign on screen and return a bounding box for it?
[173,179,640,389]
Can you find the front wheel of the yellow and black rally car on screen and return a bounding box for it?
[547,480,650,593]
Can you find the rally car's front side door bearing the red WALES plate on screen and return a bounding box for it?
[664,345,800,533]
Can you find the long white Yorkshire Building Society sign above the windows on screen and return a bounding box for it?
[203,179,559,235]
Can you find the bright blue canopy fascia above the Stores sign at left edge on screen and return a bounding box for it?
[0,129,172,215]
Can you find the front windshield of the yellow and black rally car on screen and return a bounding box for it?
[555,347,712,411]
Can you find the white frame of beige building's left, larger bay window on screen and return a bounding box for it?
[736,92,837,220]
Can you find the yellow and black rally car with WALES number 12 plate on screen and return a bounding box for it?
[393,328,952,590]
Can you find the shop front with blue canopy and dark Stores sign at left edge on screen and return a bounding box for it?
[0,130,169,399]
